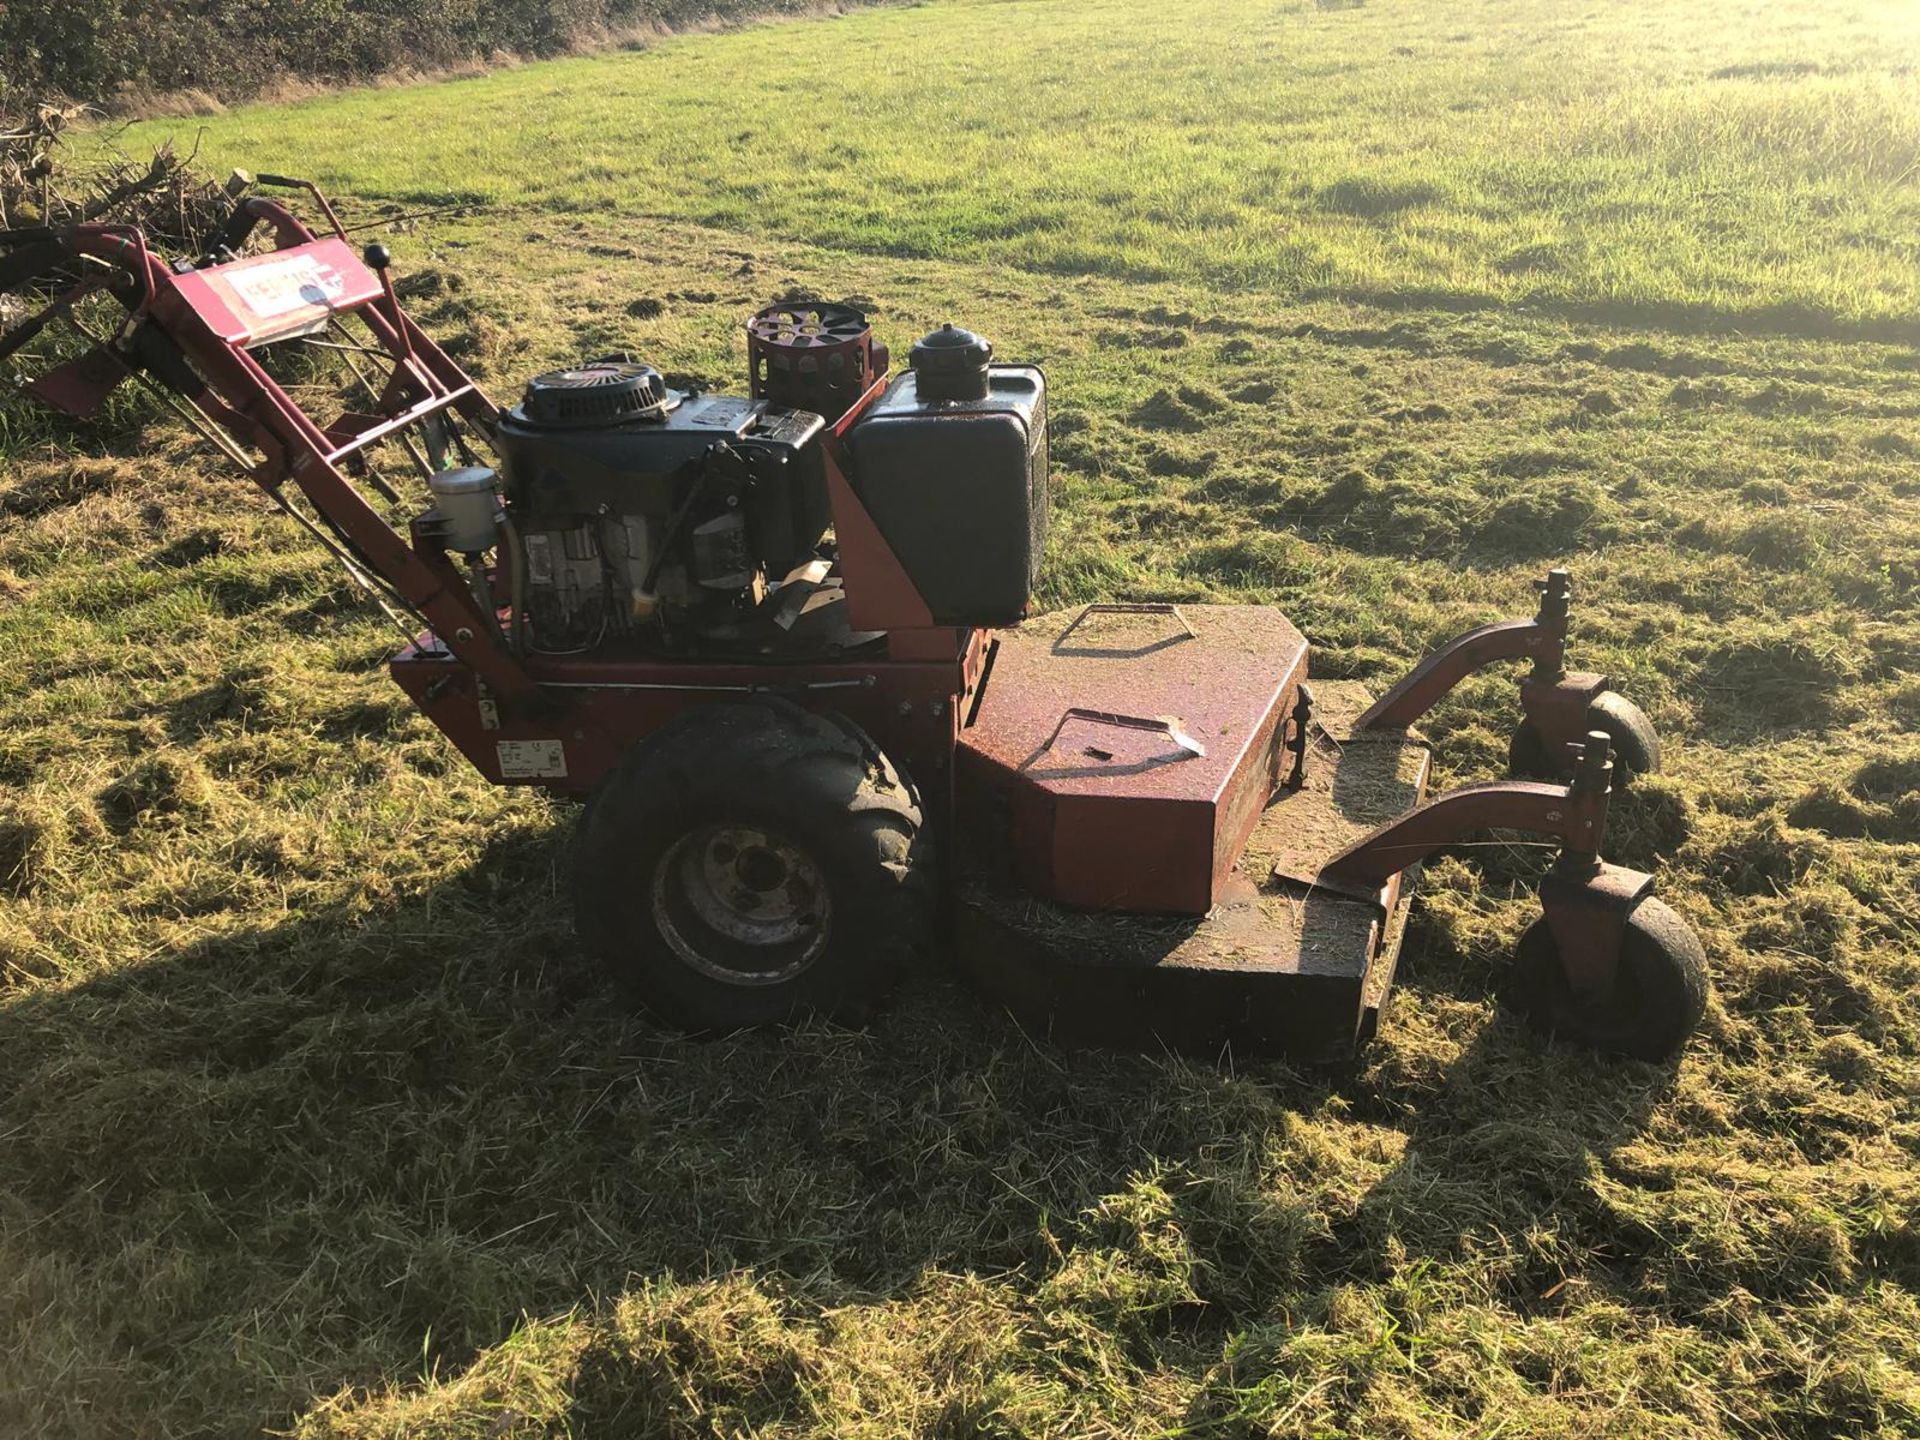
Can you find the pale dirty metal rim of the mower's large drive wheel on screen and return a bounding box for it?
[651,824,831,985]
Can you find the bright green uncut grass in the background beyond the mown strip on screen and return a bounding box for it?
[129,0,1920,328]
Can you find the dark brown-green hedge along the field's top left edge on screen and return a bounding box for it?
[0,0,840,104]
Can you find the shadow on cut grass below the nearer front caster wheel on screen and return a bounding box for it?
[1152,1023,1672,1434]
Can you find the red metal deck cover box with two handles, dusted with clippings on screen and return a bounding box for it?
[958,605,1308,914]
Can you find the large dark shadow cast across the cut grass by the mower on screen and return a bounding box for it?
[0,831,1681,1432]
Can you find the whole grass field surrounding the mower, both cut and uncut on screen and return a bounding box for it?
[0,0,1920,1440]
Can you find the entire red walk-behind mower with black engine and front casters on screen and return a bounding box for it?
[0,175,1705,1058]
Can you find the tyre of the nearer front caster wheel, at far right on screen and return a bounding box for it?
[1503,895,1707,1060]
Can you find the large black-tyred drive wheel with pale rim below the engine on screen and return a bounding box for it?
[574,699,931,1033]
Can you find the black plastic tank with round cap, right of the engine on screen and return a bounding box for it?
[849,326,1046,626]
